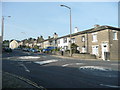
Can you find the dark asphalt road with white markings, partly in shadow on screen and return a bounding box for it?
[2,50,120,88]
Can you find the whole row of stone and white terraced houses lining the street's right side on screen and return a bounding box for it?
[28,25,120,60]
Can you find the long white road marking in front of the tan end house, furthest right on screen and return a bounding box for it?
[79,66,111,71]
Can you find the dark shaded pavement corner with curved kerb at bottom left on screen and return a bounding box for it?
[2,72,37,89]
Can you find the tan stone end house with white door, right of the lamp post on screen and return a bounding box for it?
[72,25,120,60]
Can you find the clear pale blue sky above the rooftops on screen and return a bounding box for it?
[0,2,118,40]
